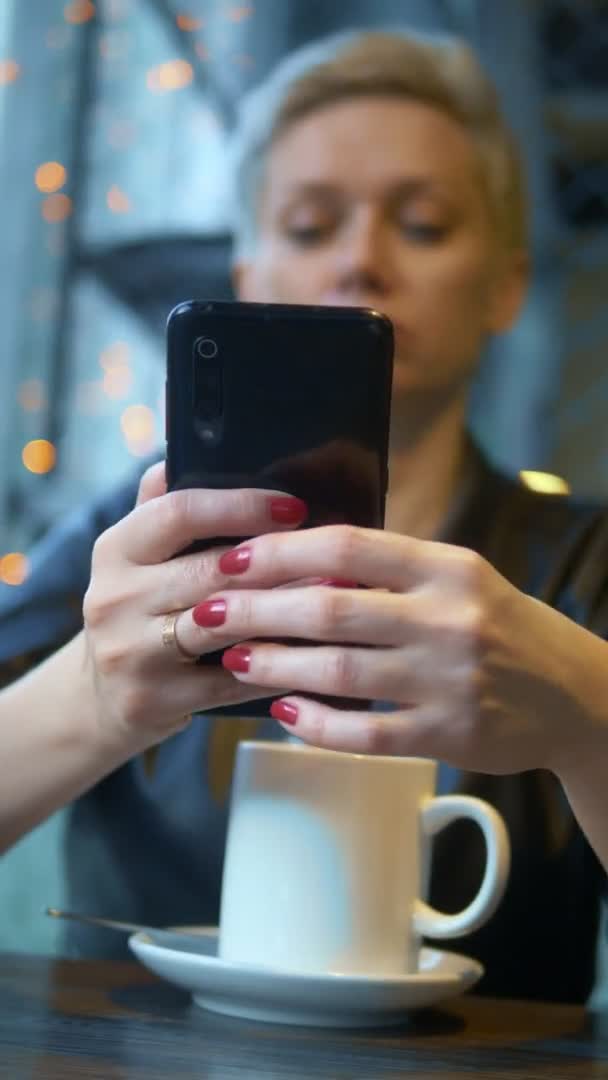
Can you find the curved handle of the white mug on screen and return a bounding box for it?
[414,795,511,939]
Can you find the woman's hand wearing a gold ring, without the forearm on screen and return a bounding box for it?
[83,463,306,754]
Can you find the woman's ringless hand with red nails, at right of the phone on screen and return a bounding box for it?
[191,526,608,773]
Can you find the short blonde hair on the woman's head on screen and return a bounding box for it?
[231,31,527,255]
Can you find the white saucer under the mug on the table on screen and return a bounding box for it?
[129,927,484,1027]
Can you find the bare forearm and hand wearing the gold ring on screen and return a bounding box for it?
[0,465,298,851]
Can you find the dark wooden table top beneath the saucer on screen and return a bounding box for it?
[0,955,608,1080]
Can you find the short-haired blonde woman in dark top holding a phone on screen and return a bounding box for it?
[0,33,608,1000]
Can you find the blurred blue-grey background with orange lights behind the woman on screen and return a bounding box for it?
[0,0,608,980]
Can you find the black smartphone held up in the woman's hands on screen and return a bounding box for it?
[166,300,393,713]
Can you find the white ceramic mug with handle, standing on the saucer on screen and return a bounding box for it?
[219,741,510,975]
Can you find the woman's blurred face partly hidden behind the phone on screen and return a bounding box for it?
[235,97,524,395]
